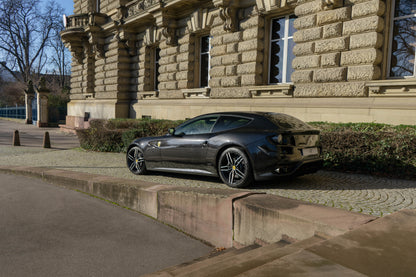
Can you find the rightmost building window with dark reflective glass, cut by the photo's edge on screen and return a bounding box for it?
[389,0,416,78]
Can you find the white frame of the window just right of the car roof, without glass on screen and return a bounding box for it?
[266,12,295,85]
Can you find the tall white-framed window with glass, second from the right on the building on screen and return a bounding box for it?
[268,15,296,84]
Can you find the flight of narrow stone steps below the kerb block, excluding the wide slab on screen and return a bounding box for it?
[149,236,324,277]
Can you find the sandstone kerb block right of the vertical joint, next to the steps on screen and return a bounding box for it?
[234,195,374,245]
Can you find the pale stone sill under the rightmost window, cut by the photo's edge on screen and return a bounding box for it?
[366,78,416,97]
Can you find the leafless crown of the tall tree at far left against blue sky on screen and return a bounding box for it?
[0,0,63,83]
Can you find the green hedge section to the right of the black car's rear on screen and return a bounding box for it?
[311,122,416,178]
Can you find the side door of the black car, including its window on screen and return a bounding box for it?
[158,116,218,170]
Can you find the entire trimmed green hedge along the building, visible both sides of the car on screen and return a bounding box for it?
[77,119,416,178]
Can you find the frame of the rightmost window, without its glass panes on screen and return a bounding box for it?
[385,0,416,79]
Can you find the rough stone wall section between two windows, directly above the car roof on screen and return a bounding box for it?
[210,7,264,98]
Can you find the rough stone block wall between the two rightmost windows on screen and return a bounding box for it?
[292,0,385,97]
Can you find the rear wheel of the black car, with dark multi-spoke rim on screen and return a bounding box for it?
[218,147,253,188]
